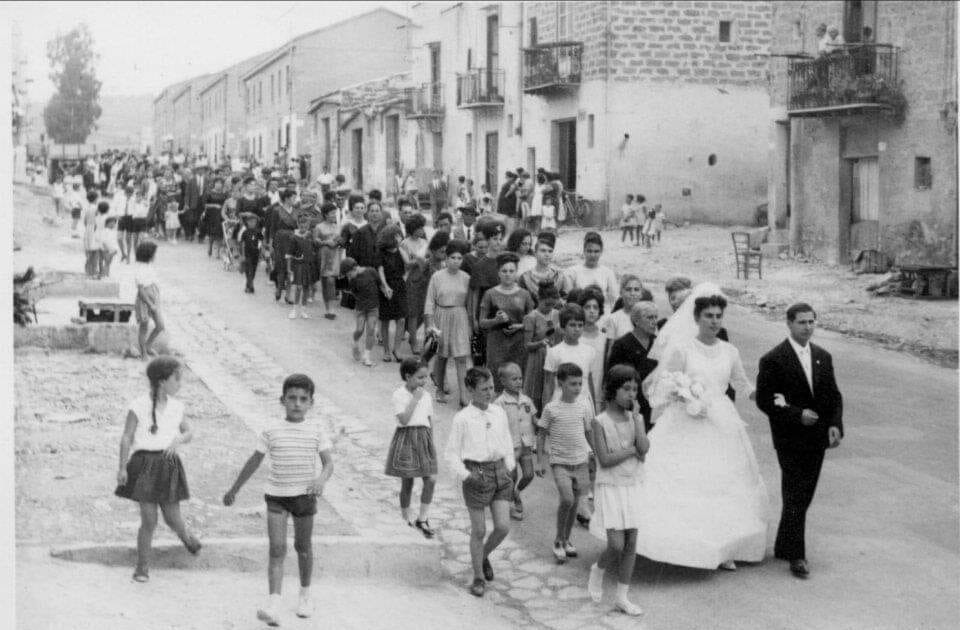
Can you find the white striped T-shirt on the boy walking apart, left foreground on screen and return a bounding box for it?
[257,419,333,497]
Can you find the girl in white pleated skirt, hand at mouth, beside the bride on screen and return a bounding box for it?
[587,365,650,616]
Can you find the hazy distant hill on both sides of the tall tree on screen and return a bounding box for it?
[27,94,153,151]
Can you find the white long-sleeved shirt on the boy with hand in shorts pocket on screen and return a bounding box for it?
[446,404,516,479]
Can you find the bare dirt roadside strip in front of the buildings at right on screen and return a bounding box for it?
[557,225,960,368]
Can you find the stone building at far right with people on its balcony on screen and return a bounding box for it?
[770,1,957,265]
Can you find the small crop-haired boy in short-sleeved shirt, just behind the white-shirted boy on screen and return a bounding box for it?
[493,363,537,521]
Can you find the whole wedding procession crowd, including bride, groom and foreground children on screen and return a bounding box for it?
[77,149,842,623]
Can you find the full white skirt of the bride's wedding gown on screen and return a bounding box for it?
[637,398,767,569]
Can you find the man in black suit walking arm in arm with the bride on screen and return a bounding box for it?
[757,303,843,578]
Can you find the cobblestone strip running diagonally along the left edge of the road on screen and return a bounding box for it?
[164,274,652,630]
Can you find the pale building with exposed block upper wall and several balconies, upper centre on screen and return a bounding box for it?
[404,1,771,223]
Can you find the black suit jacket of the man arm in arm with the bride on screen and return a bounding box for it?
[757,340,843,451]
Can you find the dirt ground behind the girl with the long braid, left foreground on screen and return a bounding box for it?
[14,348,352,546]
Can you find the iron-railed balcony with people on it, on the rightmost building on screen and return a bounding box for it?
[787,44,905,118]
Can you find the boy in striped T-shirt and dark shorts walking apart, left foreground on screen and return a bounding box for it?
[223,374,333,626]
